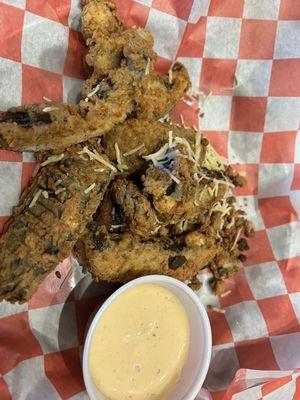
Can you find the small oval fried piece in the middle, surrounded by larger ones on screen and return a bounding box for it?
[111,178,160,239]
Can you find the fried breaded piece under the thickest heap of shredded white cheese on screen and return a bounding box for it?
[103,120,242,224]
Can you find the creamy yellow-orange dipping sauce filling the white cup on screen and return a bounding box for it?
[89,284,190,400]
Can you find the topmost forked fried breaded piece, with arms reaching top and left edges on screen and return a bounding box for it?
[0,0,190,152]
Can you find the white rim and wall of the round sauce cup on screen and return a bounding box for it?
[82,275,212,400]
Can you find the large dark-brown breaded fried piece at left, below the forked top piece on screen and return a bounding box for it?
[0,145,113,303]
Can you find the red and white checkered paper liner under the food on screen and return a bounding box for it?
[0,0,300,400]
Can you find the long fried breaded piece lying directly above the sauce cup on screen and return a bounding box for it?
[75,225,219,282]
